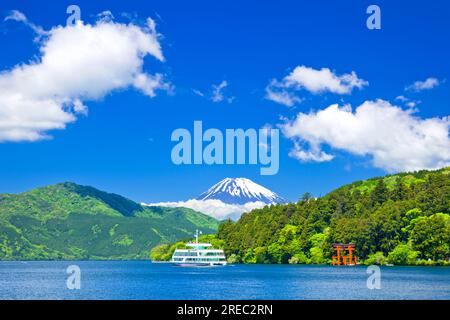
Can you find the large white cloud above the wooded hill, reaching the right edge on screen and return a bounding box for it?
[280,100,450,172]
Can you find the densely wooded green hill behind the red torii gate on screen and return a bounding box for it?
[217,168,450,265]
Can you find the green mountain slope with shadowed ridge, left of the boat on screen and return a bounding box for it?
[0,182,218,260]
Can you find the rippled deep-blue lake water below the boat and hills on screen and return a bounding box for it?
[0,261,450,299]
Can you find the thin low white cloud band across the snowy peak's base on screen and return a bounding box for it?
[142,199,267,220]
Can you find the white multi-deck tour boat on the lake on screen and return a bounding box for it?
[170,230,227,267]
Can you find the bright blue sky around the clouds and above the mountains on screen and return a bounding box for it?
[0,0,450,202]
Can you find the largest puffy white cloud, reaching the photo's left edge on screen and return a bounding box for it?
[0,11,169,141]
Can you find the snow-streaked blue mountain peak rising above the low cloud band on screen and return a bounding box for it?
[197,178,285,204]
